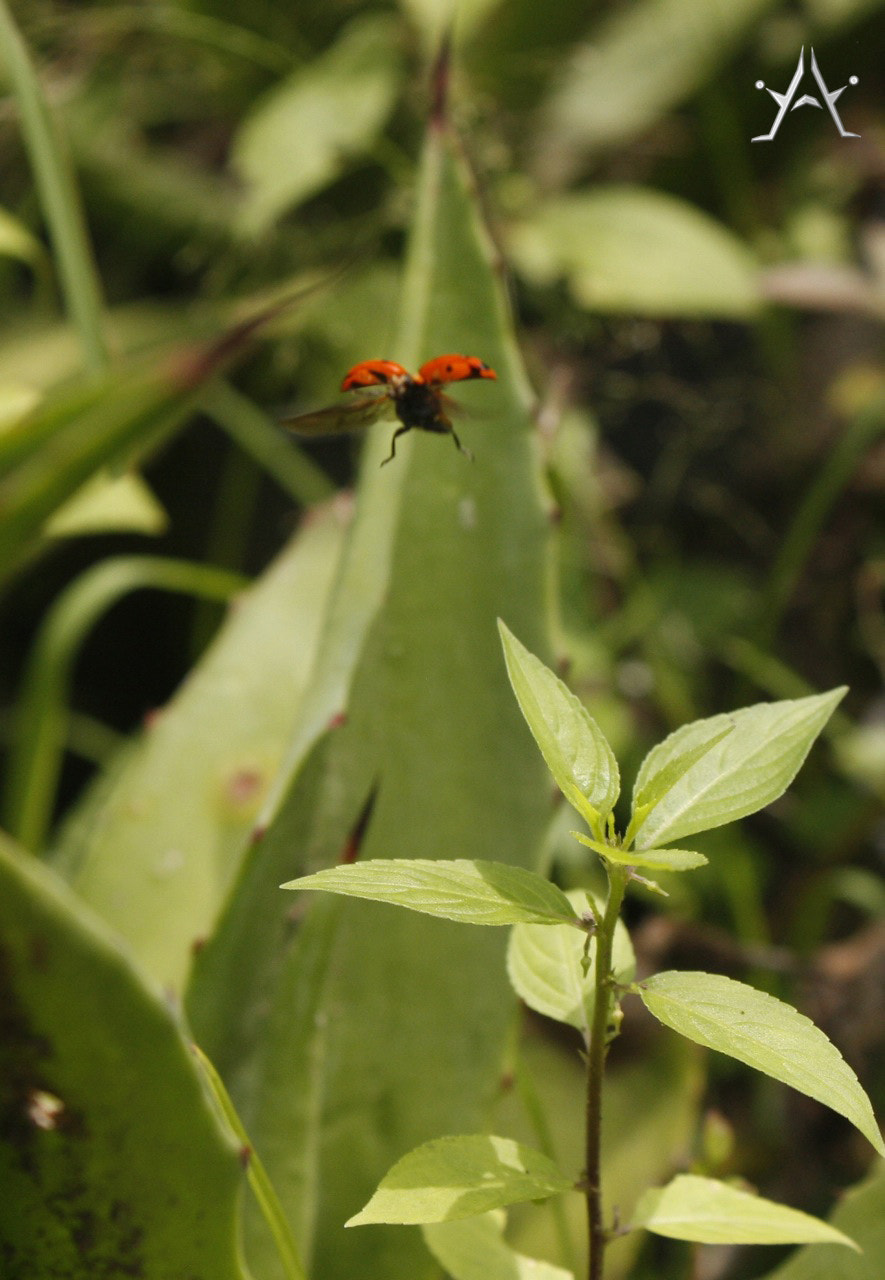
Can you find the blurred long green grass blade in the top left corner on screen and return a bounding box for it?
[0,0,108,371]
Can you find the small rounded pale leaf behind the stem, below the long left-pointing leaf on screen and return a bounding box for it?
[507,890,637,1039]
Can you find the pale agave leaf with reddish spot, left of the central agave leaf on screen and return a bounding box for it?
[50,507,342,989]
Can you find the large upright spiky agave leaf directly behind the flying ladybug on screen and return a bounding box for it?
[188,104,548,1280]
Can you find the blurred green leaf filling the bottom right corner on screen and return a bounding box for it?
[765,1166,885,1280]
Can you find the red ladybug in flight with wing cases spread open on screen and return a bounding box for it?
[283,356,498,466]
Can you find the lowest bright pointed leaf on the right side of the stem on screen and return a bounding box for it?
[631,1174,859,1252]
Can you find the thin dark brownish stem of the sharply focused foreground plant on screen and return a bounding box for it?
[584,865,630,1280]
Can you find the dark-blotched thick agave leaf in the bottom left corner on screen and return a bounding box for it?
[0,841,242,1280]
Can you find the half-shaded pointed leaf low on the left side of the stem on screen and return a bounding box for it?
[345,1134,572,1226]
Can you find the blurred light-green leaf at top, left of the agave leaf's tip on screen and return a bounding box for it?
[233,15,400,234]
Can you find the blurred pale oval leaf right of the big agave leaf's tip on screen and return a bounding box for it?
[508,186,759,319]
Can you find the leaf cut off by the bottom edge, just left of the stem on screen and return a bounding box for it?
[421,1210,574,1280]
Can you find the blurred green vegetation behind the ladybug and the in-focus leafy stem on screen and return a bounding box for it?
[0,0,885,1280]
